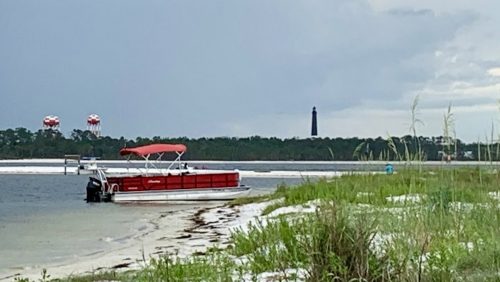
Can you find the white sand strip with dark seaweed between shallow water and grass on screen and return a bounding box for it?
[0,202,263,281]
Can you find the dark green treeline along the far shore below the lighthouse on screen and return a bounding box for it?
[0,128,494,161]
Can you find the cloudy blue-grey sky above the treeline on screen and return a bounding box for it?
[0,0,500,142]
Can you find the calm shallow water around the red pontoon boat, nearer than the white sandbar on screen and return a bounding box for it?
[0,167,302,272]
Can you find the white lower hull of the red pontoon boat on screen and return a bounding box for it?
[111,187,251,203]
